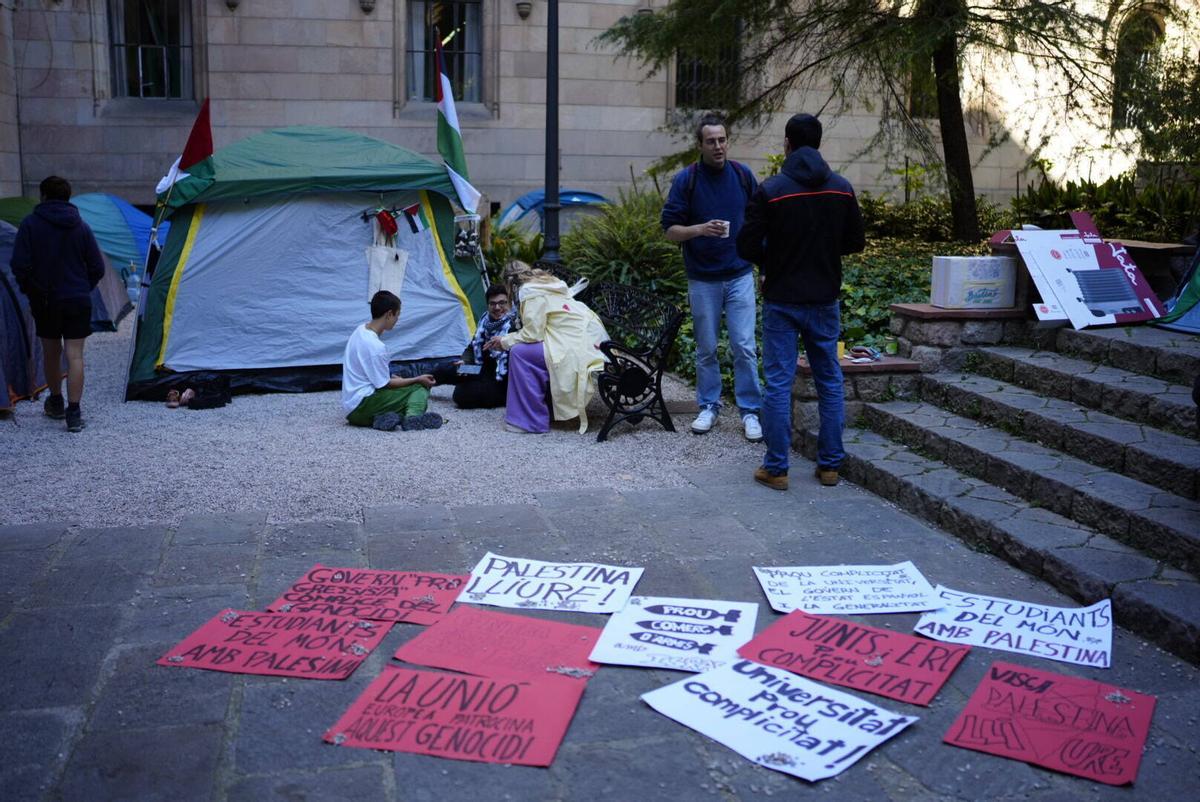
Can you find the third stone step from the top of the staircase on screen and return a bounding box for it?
[920,372,1200,499]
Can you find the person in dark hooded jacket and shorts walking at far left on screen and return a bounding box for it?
[10,175,104,432]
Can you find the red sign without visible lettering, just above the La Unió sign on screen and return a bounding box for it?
[395,606,601,680]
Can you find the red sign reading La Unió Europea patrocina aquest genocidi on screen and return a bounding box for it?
[325,662,584,766]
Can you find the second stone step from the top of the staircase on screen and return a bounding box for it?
[966,346,1200,438]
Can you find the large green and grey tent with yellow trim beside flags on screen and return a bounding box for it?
[126,126,484,399]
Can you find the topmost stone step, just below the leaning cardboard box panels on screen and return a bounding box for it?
[1054,325,1200,387]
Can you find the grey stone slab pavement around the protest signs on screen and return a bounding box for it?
[0,460,1200,802]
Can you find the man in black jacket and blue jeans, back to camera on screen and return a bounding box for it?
[738,114,866,490]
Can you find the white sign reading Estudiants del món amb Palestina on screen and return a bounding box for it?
[914,585,1112,669]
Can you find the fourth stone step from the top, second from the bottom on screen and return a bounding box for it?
[862,401,1200,575]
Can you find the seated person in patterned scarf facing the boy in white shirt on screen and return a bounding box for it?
[433,285,521,409]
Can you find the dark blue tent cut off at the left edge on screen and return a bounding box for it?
[0,220,46,412]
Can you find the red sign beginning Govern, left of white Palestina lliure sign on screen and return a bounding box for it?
[266,563,470,624]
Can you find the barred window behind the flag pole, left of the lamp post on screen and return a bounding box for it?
[406,0,484,103]
